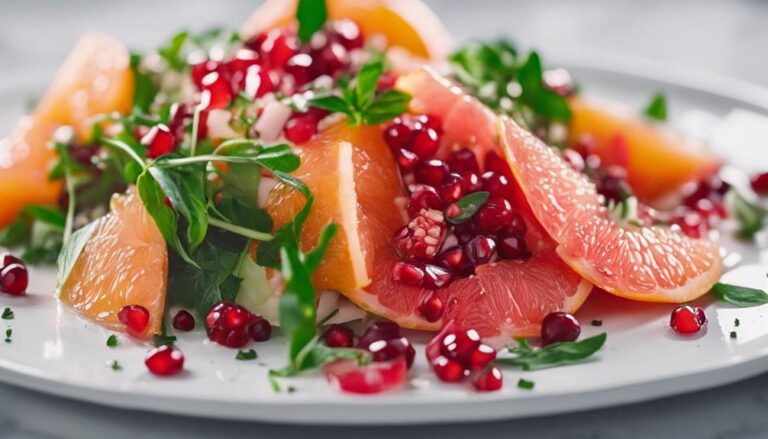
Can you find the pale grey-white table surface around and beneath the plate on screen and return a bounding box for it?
[0,0,768,439]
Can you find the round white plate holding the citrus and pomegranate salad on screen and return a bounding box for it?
[0,52,768,424]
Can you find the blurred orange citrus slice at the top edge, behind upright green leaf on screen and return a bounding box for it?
[240,0,451,59]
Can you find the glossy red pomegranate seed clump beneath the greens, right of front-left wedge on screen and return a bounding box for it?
[205,302,257,348]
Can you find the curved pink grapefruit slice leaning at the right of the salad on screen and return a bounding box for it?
[501,118,723,303]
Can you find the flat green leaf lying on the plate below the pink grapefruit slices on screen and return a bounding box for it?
[496,333,607,370]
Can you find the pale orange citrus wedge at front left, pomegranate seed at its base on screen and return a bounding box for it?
[60,187,168,336]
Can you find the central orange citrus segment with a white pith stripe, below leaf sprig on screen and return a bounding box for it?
[266,124,403,301]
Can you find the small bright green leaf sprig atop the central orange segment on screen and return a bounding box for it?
[309,59,411,125]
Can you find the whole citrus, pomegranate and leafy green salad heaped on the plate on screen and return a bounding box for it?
[0,0,768,393]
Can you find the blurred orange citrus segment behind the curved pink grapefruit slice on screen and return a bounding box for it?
[569,98,721,200]
